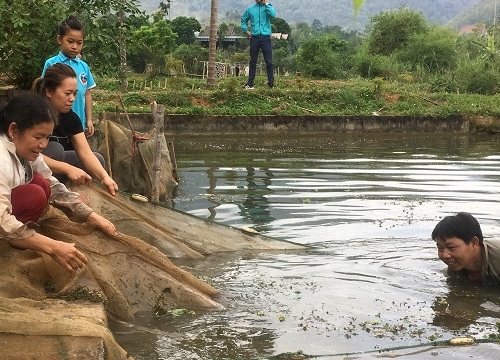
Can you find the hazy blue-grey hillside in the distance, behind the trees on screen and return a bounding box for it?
[140,0,483,30]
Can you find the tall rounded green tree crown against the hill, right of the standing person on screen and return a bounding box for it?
[368,8,428,55]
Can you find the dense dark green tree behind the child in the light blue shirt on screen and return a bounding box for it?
[0,0,145,89]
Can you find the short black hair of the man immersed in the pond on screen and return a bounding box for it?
[432,212,483,244]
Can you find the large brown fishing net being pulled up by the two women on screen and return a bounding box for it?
[0,184,302,360]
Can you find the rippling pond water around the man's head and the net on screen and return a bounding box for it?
[112,133,500,360]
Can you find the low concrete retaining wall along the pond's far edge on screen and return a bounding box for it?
[100,112,472,134]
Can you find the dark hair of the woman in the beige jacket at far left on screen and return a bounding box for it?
[0,92,59,134]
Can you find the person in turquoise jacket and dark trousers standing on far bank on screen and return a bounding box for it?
[241,0,276,90]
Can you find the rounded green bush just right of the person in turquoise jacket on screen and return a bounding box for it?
[297,35,347,79]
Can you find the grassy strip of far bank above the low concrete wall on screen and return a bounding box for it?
[93,76,500,117]
